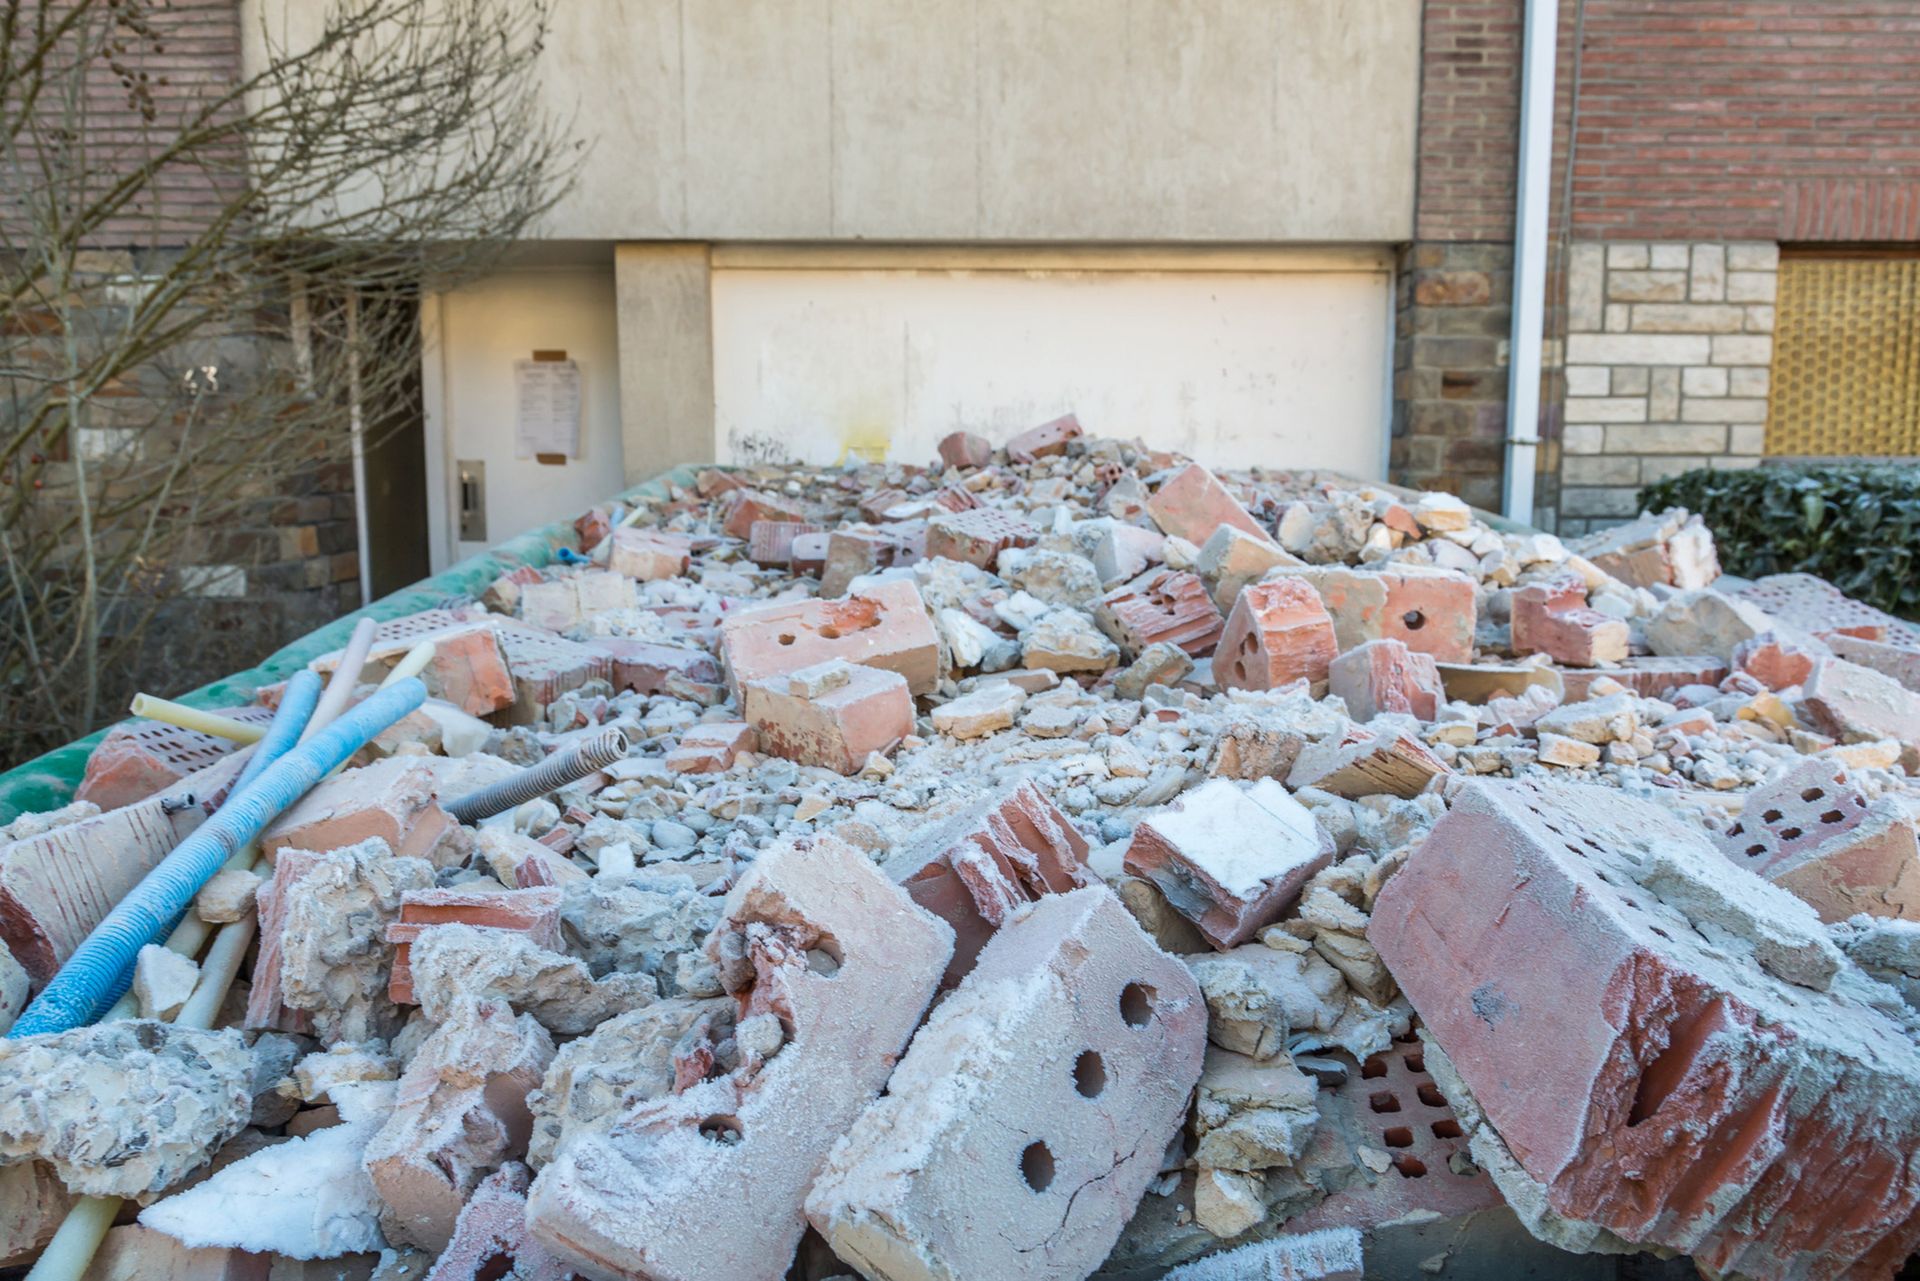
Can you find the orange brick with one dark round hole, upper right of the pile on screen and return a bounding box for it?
[1273,565,1478,663]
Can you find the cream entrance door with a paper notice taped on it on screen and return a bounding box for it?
[426,261,624,570]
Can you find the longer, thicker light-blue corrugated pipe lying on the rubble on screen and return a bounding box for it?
[8,678,426,1037]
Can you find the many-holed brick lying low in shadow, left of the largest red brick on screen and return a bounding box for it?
[1286,1031,1501,1231]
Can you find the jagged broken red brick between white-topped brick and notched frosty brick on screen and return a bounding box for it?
[883,782,1094,987]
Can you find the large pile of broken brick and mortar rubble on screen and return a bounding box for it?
[0,417,1920,1281]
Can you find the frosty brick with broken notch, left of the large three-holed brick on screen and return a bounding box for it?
[526,837,952,1281]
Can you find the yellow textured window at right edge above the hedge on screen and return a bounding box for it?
[1766,255,1920,457]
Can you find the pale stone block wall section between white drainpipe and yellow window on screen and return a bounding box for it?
[1559,240,1780,534]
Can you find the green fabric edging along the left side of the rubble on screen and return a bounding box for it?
[0,467,699,824]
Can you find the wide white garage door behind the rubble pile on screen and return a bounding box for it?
[712,252,1392,476]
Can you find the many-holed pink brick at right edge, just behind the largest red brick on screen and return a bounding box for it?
[1715,759,1920,924]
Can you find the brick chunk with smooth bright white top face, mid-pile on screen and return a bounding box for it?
[1123,778,1334,951]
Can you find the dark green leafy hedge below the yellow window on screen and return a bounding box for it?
[1640,463,1920,620]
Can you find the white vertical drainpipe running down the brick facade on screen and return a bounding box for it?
[1501,0,1559,524]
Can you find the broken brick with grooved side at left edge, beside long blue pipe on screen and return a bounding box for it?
[0,755,242,985]
